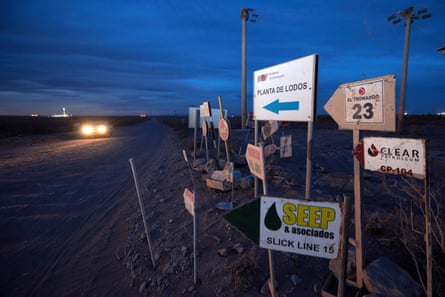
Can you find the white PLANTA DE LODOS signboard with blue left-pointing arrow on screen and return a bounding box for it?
[253,55,318,122]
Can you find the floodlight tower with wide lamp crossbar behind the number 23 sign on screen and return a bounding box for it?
[387,6,432,133]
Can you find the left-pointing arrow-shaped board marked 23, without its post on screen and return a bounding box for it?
[325,75,395,131]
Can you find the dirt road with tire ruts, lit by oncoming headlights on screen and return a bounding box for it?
[0,120,173,297]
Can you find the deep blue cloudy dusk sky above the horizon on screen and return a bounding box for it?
[0,0,445,115]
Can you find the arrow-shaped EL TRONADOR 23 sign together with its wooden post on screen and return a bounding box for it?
[324,74,396,288]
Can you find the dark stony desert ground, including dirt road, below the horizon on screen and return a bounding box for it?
[0,117,445,297]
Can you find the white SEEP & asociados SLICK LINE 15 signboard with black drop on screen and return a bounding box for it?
[260,197,342,259]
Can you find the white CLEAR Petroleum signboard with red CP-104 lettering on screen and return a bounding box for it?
[363,137,426,179]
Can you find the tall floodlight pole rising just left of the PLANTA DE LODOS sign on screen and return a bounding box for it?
[241,8,258,129]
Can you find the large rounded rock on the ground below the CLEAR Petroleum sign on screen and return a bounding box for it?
[363,257,424,297]
